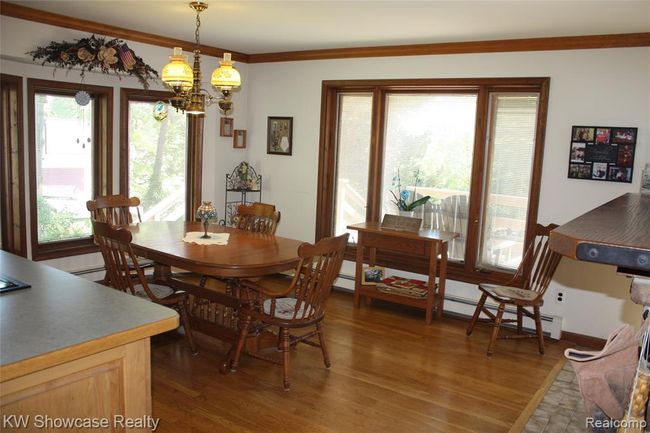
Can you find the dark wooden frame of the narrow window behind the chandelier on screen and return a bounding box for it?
[120,88,204,221]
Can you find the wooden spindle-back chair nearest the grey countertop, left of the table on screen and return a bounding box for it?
[92,220,197,354]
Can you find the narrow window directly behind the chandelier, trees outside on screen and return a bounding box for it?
[121,89,188,221]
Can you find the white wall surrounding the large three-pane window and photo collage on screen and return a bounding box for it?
[248,48,650,337]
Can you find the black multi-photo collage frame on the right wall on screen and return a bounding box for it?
[569,126,637,183]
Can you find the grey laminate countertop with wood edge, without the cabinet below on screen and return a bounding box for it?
[0,251,178,382]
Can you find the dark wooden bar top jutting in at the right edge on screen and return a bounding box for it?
[550,193,650,265]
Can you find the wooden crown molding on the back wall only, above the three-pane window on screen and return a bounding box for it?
[248,33,650,63]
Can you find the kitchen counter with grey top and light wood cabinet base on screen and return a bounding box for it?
[0,251,178,431]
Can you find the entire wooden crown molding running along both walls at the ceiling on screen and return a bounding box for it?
[0,1,650,63]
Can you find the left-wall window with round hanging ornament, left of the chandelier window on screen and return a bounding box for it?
[27,79,112,260]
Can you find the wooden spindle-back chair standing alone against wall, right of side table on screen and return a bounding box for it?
[467,224,562,356]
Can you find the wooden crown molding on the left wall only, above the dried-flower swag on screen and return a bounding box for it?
[0,1,248,62]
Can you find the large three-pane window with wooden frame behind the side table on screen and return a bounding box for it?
[316,78,549,282]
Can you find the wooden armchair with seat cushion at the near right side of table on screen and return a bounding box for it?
[231,233,348,391]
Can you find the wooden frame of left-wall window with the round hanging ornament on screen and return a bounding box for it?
[27,78,113,260]
